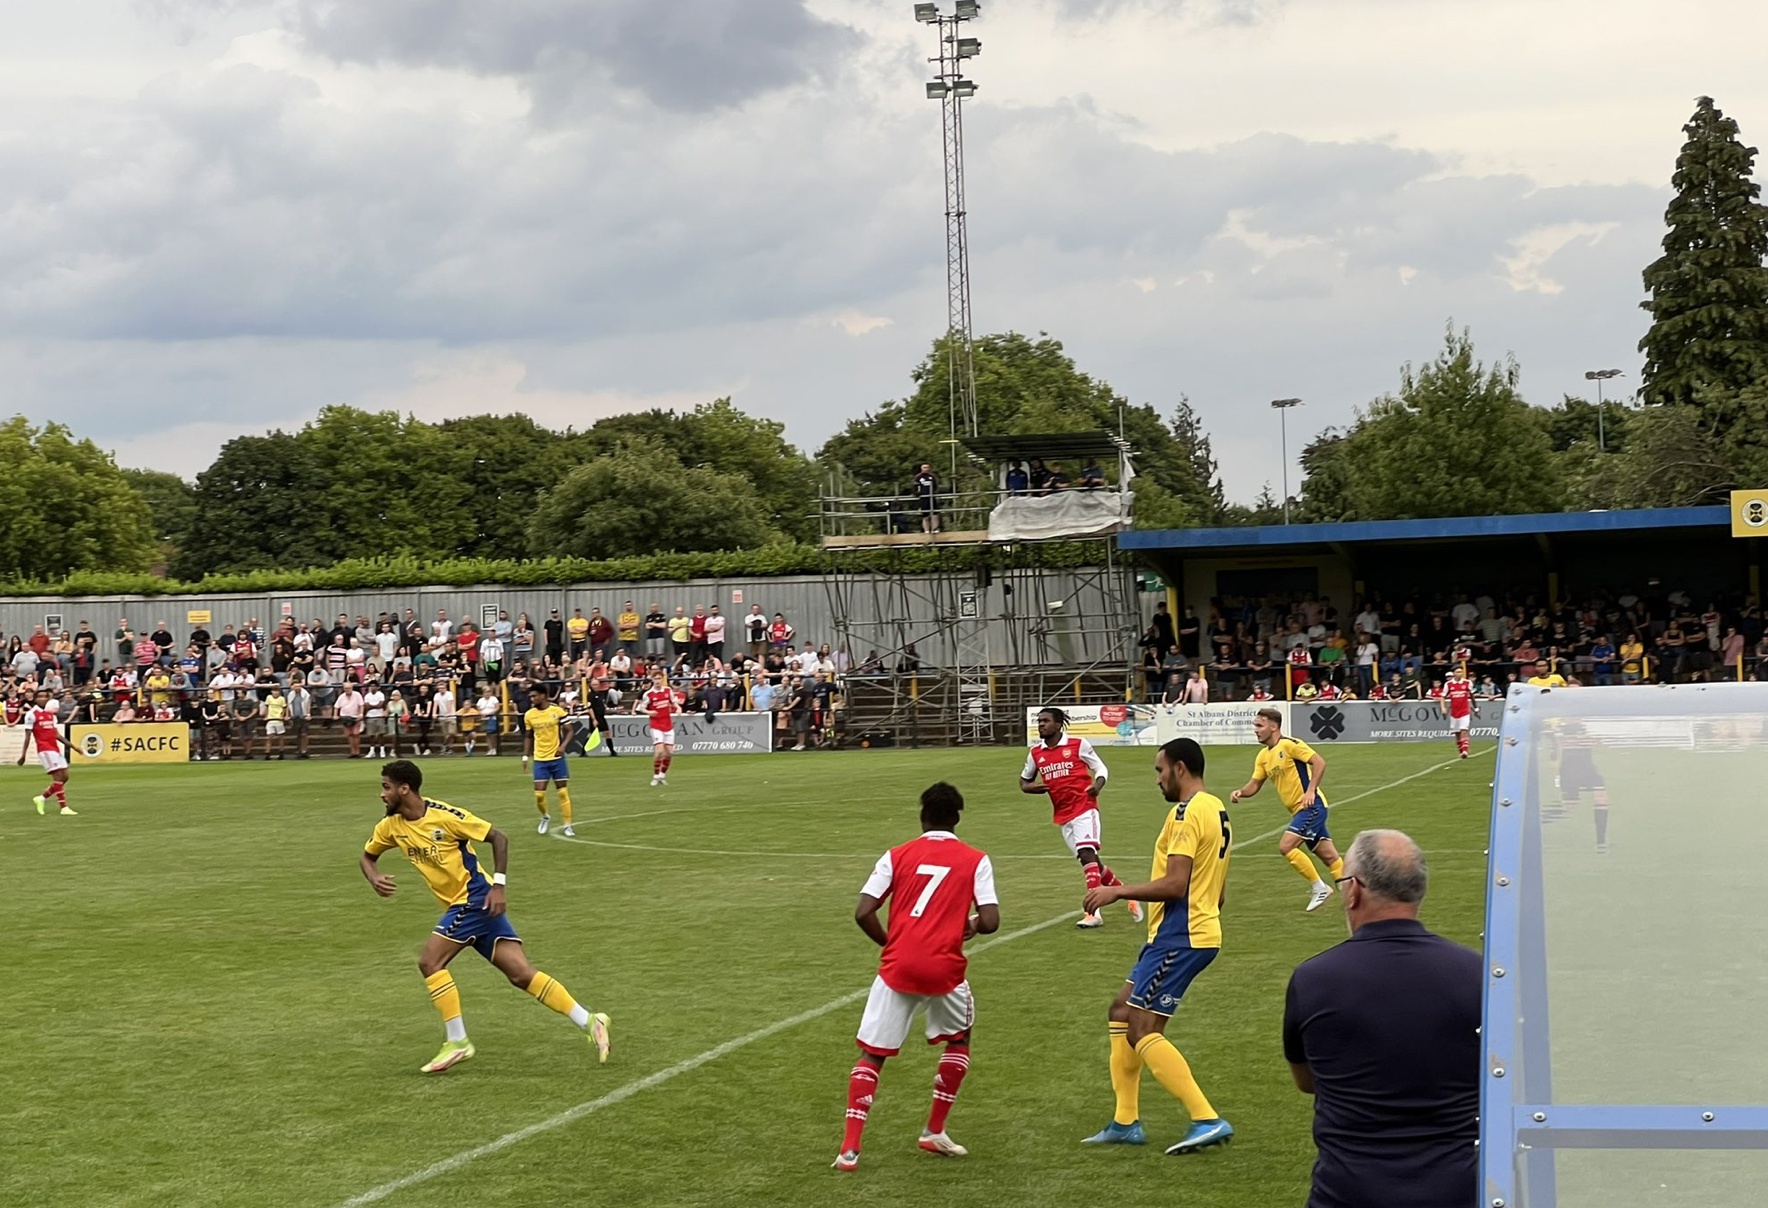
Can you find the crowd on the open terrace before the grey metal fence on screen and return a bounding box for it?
[0,601,862,759]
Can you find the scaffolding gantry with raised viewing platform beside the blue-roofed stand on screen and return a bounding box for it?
[820,432,1142,745]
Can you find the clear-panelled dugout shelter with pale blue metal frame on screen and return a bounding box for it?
[1478,683,1768,1208]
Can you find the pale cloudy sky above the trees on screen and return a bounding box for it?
[0,0,1768,501]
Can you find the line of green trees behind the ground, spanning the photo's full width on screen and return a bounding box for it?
[0,97,1768,582]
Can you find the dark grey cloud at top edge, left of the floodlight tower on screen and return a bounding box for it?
[292,0,857,111]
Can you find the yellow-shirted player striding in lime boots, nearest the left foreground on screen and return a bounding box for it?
[361,759,608,1074]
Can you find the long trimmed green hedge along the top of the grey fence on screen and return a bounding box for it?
[0,541,1131,596]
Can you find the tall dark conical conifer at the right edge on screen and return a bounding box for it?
[1639,97,1768,410]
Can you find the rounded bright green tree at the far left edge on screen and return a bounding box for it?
[0,416,154,578]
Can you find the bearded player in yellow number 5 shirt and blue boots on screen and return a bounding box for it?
[1084,738,1234,1153]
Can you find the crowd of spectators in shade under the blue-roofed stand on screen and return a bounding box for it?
[1142,591,1768,704]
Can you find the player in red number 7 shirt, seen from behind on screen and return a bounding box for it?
[834,782,1001,1171]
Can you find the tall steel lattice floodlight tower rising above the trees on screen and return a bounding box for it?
[914,0,983,445]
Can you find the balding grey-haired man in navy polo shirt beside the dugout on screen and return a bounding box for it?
[1284,831,1482,1208]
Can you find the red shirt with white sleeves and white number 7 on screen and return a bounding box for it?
[863,831,999,994]
